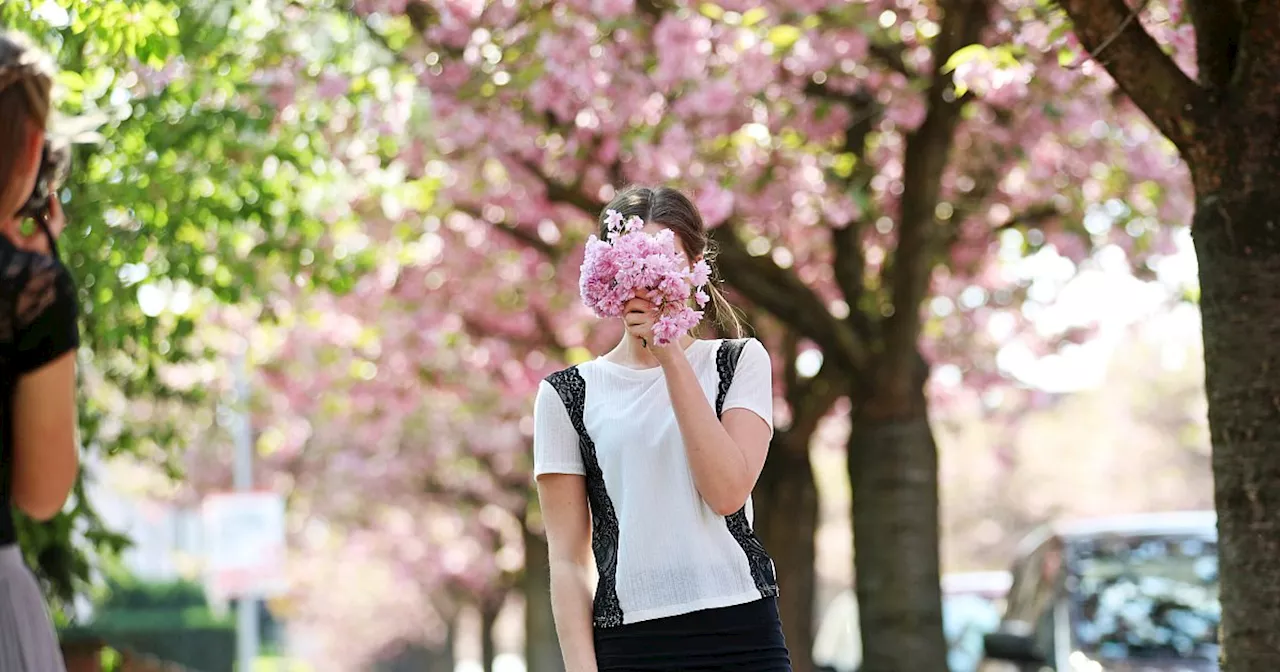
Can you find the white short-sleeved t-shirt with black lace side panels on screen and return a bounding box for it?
[534,339,778,627]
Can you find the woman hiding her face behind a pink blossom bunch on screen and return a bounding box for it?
[534,187,791,672]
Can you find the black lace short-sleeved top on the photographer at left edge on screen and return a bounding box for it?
[0,236,79,547]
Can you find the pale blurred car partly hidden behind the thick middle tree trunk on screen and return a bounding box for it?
[813,571,1010,672]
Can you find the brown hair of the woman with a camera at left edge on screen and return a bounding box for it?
[0,32,54,216]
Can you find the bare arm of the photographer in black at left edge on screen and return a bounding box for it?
[13,351,79,521]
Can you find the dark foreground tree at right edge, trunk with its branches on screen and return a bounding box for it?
[1039,0,1280,671]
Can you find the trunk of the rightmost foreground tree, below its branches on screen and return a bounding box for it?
[1192,185,1280,672]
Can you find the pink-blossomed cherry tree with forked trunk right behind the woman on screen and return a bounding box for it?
[340,0,1180,669]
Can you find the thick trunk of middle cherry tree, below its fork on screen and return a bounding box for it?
[849,392,947,672]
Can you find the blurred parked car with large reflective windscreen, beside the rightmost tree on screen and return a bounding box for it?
[979,511,1221,672]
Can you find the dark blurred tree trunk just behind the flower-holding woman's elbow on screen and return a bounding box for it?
[751,431,818,672]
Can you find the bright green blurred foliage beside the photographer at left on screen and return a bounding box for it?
[0,0,384,599]
